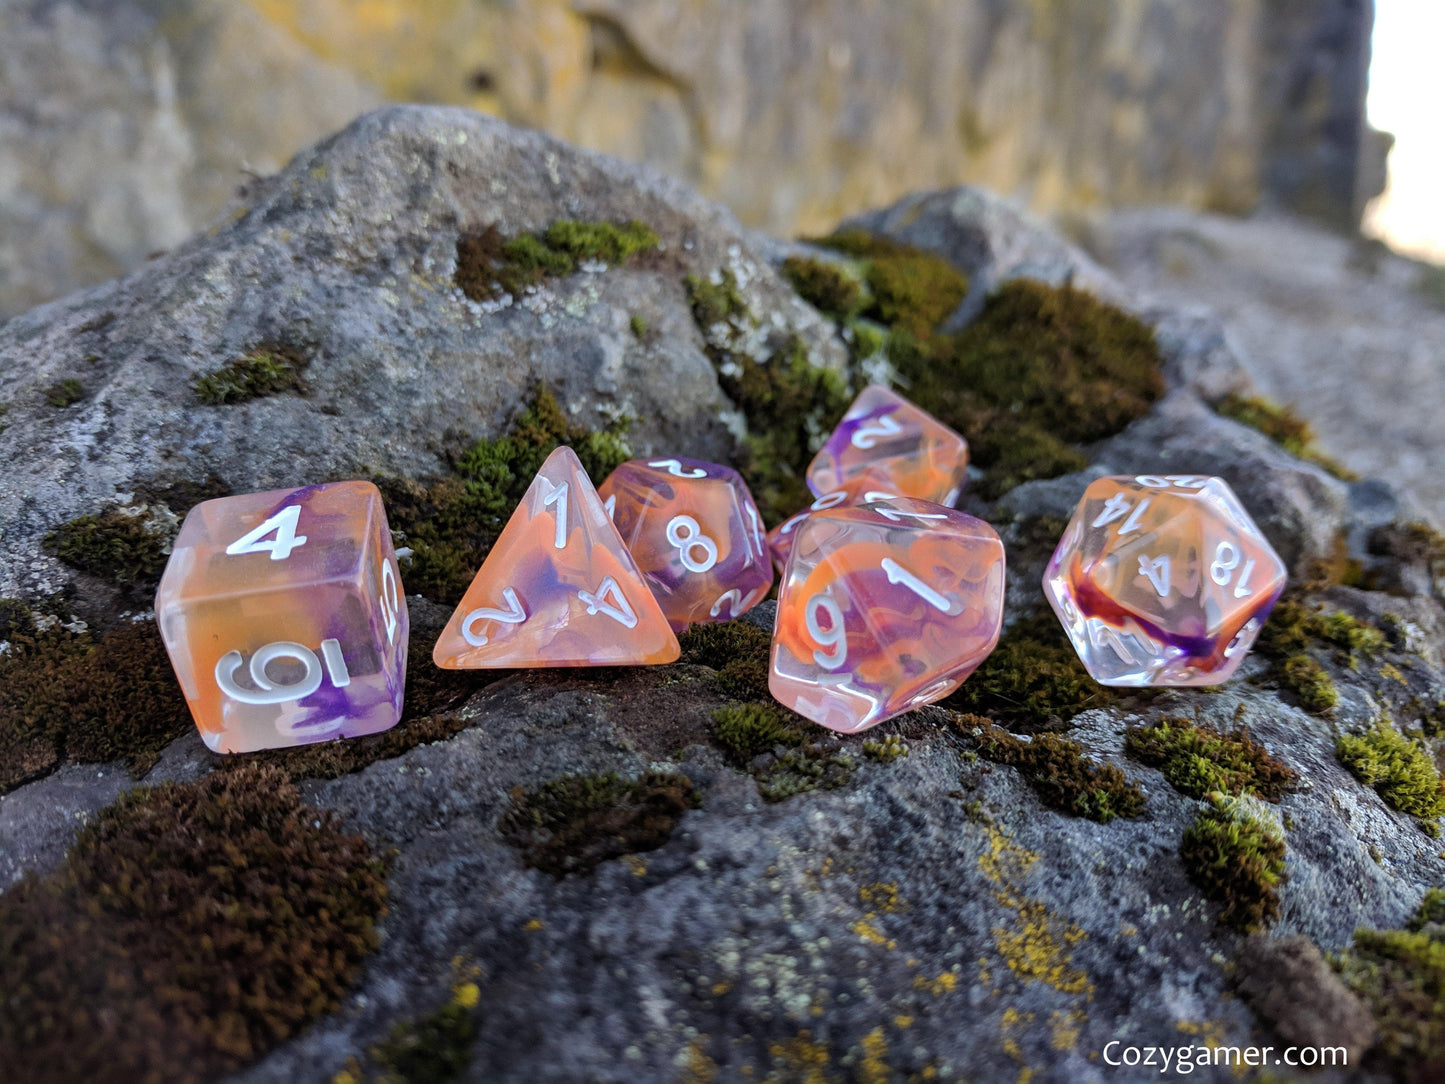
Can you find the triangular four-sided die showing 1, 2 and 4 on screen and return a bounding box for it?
[432,447,681,669]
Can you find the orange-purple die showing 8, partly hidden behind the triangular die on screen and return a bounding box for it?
[597,458,773,632]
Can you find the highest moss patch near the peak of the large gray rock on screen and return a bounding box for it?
[455,218,657,301]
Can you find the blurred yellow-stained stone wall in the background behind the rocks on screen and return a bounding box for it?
[0,0,1384,317]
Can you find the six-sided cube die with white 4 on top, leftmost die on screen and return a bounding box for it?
[156,481,409,753]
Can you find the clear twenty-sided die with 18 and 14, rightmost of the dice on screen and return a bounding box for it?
[1043,474,1285,685]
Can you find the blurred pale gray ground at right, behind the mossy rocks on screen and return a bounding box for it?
[1082,210,1445,522]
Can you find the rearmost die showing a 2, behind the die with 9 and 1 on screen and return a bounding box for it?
[808,384,968,506]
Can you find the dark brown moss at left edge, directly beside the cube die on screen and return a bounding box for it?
[0,618,192,793]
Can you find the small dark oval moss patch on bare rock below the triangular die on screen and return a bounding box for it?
[497,772,701,877]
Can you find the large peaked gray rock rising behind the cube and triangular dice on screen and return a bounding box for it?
[0,107,844,595]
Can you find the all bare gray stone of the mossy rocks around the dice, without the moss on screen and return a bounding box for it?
[0,107,1445,1083]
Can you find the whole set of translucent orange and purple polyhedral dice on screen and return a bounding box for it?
[156,386,1285,753]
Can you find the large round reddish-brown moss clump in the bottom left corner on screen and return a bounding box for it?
[0,767,386,1081]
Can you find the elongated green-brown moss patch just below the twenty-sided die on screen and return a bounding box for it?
[1124,718,1298,802]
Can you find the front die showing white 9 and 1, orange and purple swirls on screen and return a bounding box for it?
[769,499,1004,733]
